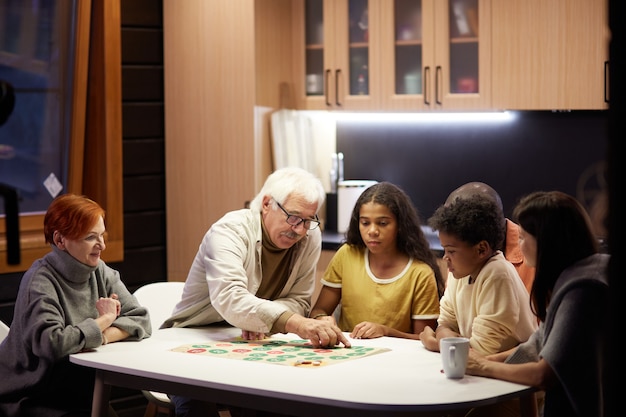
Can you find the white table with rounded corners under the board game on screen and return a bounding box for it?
[70,327,535,417]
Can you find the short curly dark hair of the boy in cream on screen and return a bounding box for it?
[428,195,506,249]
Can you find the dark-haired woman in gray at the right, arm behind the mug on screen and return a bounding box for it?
[466,191,609,417]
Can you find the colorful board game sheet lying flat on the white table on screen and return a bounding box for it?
[171,338,390,368]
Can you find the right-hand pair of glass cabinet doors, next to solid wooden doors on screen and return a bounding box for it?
[381,0,491,110]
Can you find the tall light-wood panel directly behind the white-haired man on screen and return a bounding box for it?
[163,0,259,280]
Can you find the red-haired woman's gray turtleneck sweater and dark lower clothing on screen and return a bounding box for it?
[0,246,152,416]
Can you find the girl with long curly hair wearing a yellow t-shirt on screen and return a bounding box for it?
[311,182,445,339]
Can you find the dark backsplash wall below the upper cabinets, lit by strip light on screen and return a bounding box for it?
[337,111,608,220]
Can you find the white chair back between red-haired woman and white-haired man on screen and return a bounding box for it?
[134,281,185,331]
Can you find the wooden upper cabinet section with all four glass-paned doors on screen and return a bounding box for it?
[293,0,491,111]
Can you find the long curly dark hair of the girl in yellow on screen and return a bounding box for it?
[346,182,445,298]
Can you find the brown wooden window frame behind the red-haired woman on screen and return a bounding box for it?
[0,0,124,273]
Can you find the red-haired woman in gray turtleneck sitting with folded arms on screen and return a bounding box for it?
[0,194,152,417]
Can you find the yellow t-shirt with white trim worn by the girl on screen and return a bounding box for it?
[322,244,439,333]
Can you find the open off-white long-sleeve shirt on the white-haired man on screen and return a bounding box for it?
[161,209,322,333]
